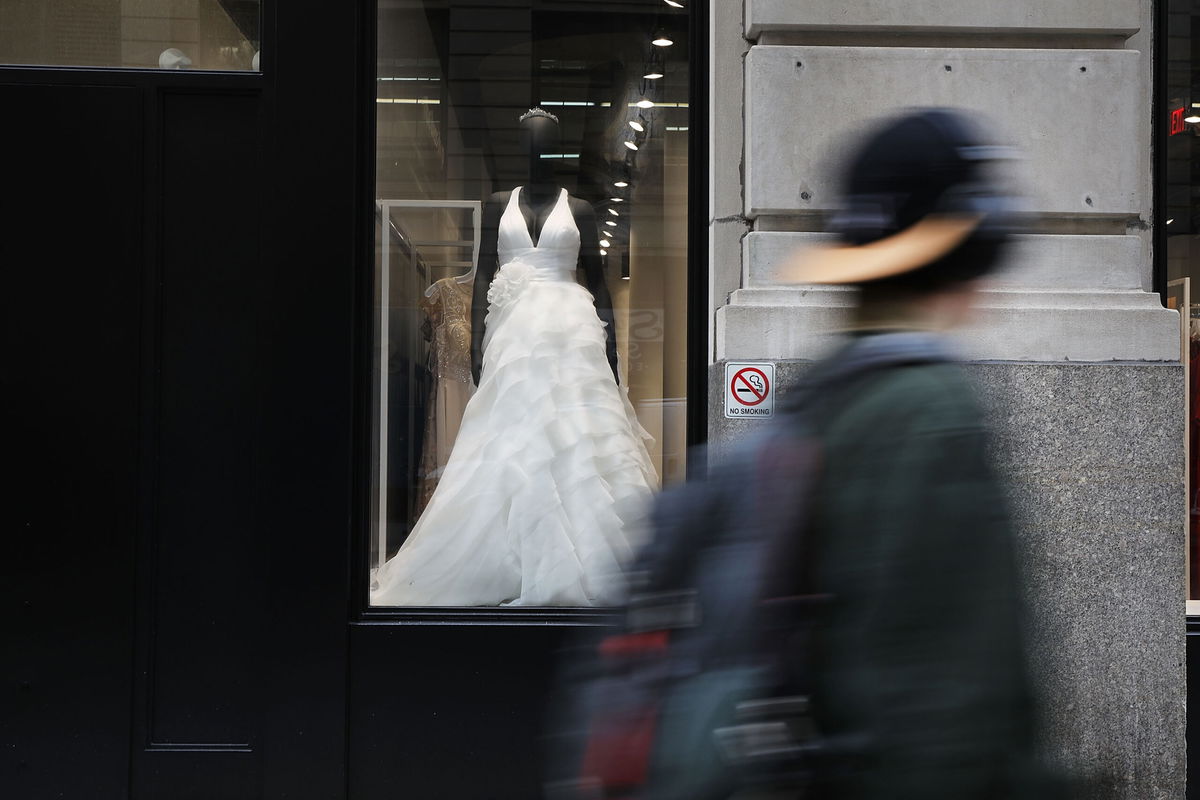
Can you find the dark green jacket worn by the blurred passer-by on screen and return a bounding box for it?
[812,335,1050,800]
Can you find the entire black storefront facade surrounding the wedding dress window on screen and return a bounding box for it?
[0,0,707,800]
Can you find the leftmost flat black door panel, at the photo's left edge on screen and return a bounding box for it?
[0,85,143,798]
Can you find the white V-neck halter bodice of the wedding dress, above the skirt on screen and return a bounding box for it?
[497,186,580,281]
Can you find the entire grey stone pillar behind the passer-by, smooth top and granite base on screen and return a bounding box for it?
[710,0,1186,798]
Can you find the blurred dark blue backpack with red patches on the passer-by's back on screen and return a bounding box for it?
[547,333,946,800]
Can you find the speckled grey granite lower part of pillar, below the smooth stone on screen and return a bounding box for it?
[709,361,1187,800]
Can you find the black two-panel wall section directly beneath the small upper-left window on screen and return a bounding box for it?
[0,70,274,798]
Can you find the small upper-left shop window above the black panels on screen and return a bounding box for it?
[0,0,262,71]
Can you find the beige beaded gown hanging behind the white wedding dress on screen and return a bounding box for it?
[416,278,475,515]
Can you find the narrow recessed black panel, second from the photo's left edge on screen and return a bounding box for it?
[133,88,265,800]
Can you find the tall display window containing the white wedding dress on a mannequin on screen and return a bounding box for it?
[367,0,690,607]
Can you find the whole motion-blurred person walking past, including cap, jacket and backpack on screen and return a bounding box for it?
[552,109,1062,800]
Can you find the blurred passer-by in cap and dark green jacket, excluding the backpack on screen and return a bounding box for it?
[768,109,1058,800]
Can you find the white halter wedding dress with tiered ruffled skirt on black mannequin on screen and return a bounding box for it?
[371,187,658,606]
